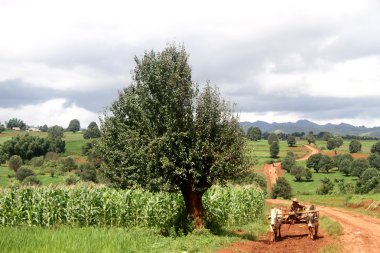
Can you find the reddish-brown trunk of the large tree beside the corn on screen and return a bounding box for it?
[181,185,204,229]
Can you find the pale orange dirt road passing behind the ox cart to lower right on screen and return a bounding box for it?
[268,199,380,253]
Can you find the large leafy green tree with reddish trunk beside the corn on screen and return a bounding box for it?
[98,45,246,227]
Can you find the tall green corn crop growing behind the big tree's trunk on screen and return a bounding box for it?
[0,187,264,228]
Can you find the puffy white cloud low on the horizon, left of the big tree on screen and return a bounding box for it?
[0,99,98,128]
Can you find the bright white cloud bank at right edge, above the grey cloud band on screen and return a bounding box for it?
[256,56,380,98]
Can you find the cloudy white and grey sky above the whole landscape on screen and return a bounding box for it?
[0,0,380,127]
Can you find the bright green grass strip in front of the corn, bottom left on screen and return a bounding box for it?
[0,227,240,253]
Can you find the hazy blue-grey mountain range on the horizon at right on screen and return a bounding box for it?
[240,120,380,137]
